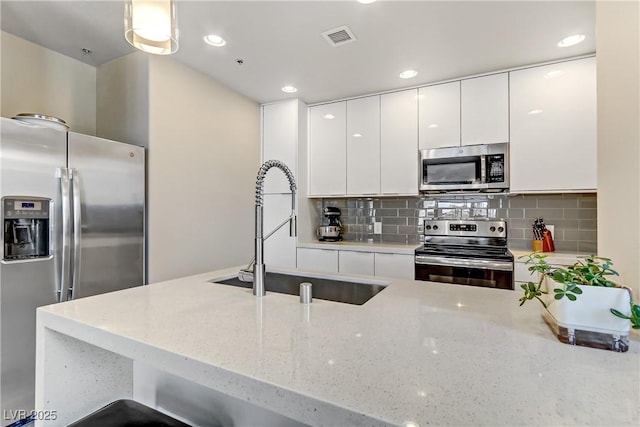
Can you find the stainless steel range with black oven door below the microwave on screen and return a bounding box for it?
[415,219,513,289]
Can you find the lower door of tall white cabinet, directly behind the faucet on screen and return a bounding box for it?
[263,194,296,268]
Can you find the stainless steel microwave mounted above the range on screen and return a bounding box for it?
[420,143,509,193]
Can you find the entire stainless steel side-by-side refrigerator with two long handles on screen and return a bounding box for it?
[0,118,145,425]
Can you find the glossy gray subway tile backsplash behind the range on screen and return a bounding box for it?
[313,193,597,253]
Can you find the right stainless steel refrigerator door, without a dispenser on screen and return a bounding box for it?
[68,132,145,298]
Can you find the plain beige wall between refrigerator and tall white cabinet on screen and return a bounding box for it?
[147,56,260,282]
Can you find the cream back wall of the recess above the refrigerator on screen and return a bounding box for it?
[0,31,96,135]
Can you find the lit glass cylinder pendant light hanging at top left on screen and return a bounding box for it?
[124,0,178,55]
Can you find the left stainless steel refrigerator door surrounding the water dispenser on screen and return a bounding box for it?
[0,118,67,418]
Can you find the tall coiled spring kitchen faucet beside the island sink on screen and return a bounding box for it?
[239,160,297,297]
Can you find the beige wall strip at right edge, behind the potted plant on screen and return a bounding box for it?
[596,1,640,301]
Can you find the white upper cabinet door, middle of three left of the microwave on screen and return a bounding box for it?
[347,96,380,195]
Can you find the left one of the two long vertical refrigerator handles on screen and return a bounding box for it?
[56,168,71,302]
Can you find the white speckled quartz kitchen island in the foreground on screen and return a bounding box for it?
[36,269,640,426]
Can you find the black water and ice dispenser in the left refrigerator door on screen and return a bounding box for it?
[2,197,51,261]
